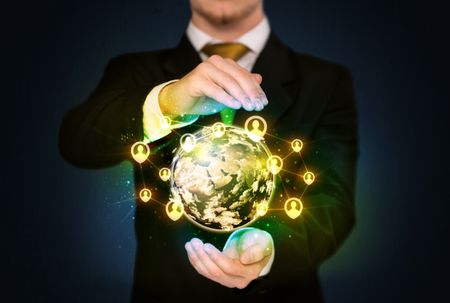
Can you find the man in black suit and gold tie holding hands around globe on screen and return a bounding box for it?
[59,0,357,302]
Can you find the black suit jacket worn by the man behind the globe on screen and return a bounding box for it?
[59,33,357,302]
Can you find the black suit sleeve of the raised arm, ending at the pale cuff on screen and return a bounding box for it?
[59,56,163,168]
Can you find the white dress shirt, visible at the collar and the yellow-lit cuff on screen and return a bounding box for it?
[143,17,270,143]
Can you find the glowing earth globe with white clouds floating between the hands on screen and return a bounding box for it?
[170,123,275,232]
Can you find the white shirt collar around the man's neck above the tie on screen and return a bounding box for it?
[186,16,270,55]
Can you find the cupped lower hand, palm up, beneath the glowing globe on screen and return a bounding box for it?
[185,228,273,289]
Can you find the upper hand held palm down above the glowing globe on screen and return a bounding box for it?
[159,55,268,116]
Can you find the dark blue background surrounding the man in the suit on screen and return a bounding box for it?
[4,0,450,302]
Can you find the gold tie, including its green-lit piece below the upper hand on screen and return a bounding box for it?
[202,42,249,125]
